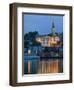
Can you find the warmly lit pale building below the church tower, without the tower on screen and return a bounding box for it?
[36,36,60,47]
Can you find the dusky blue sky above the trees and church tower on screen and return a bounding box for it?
[24,14,63,35]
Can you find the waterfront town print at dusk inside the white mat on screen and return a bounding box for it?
[23,14,63,74]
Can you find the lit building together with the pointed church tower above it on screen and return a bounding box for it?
[36,22,61,47]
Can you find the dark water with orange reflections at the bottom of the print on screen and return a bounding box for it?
[24,59,63,74]
